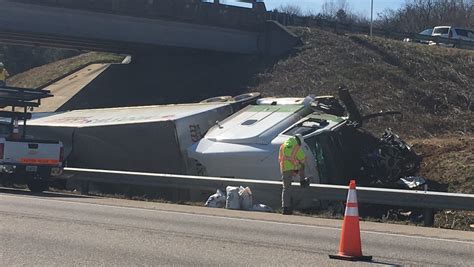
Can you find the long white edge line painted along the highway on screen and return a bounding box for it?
[0,194,474,245]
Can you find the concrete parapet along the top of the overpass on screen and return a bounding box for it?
[10,0,266,31]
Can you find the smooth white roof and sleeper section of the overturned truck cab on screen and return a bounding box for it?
[188,105,311,180]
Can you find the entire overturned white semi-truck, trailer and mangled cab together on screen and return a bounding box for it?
[24,88,421,207]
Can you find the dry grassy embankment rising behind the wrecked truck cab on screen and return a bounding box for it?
[248,28,474,138]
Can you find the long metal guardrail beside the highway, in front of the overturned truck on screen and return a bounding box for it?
[62,168,474,211]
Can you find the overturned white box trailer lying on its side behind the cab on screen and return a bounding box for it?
[28,103,236,174]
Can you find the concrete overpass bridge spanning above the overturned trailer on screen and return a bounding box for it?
[0,0,298,55]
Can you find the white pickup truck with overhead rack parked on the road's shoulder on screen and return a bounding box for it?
[0,87,64,192]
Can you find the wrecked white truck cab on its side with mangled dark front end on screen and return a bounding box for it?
[188,88,421,187]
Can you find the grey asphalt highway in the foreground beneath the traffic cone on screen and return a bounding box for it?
[0,189,474,266]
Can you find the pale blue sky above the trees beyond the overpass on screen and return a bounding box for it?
[227,0,406,17]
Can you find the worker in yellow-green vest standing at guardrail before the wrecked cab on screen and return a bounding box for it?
[278,135,305,215]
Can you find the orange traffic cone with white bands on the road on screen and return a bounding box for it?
[329,180,372,261]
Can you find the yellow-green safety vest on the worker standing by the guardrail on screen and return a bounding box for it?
[278,137,305,172]
